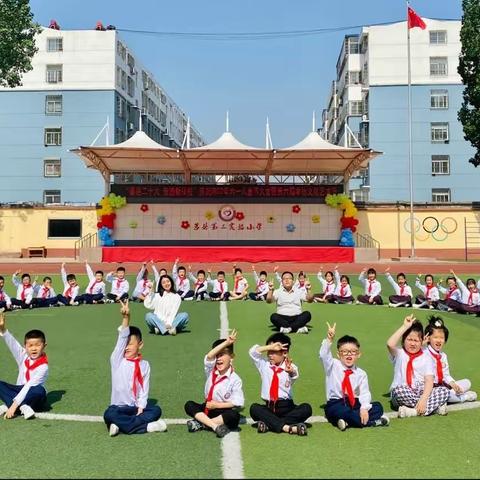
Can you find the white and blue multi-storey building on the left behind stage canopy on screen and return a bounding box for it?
[0,28,204,205]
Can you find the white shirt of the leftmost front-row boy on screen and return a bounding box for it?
[0,330,48,405]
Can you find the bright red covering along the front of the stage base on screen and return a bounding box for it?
[102,245,355,266]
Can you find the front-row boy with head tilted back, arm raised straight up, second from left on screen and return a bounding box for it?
[103,299,167,437]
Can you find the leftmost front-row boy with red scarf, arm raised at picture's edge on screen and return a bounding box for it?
[0,309,48,420]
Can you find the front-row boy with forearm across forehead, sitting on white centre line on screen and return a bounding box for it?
[185,330,245,437]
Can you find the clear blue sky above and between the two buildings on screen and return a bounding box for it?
[30,0,462,147]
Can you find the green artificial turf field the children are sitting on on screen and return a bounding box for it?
[0,286,480,478]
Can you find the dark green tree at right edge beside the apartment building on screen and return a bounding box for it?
[458,0,480,167]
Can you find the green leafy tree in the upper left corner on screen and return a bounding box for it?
[0,0,41,87]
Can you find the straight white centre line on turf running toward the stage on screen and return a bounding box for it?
[220,302,245,479]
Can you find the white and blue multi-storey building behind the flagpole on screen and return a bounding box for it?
[322,18,479,203]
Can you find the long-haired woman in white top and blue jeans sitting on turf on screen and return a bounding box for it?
[143,275,188,335]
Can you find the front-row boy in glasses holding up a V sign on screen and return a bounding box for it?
[320,322,390,431]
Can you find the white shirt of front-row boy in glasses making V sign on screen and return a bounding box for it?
[319,339,372,410]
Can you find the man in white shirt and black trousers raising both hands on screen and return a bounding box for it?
[266,272,313,333]
